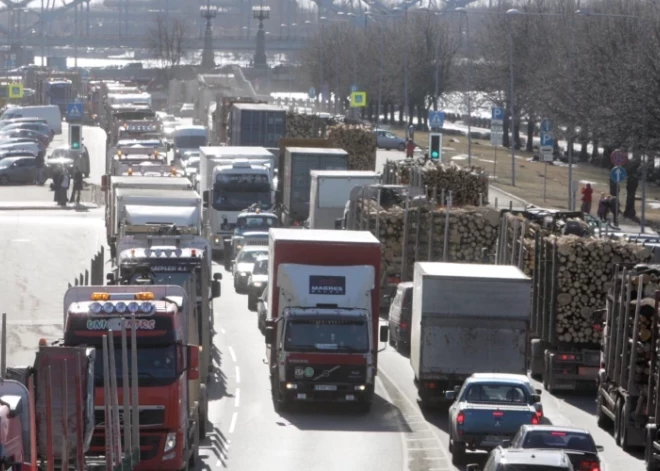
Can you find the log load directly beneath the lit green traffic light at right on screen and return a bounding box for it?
[386,158,488,206]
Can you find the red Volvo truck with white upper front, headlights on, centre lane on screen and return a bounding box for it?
[266,228,387,412]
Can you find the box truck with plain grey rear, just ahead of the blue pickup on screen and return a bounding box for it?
[410,262,532,405]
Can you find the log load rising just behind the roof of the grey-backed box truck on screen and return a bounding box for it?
[356,200,499,280]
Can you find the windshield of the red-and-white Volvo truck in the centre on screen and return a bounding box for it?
[284,319,369,353]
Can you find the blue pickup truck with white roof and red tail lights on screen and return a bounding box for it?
[446,373,543,465]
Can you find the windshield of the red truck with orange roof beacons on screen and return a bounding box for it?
[94,340,179,387]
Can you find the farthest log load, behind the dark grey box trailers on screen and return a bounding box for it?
[285,112,376,171]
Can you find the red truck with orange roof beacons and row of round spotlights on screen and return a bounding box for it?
[64,285,200,471]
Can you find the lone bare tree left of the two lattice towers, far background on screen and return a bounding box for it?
[147,13,190,80]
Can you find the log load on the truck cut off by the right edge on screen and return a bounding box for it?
[608,265,660,391]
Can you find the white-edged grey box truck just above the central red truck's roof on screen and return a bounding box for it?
[309,170,380,229]
